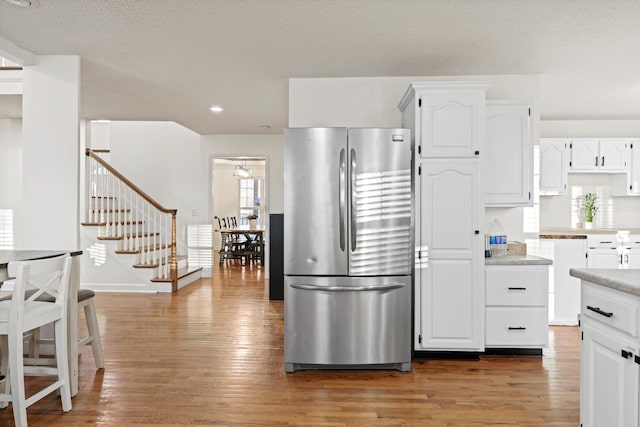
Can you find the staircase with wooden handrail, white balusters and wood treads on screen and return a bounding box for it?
[82,149,202,292]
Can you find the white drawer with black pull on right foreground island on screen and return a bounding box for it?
[580,282,639,337]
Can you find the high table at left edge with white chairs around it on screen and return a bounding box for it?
[0,250,82,396]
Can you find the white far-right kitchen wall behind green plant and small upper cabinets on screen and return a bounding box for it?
[540,120,640,228]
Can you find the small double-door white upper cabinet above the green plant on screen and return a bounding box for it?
[570,138,628,172]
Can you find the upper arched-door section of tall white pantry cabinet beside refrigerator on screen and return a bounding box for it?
[398,82,487,158]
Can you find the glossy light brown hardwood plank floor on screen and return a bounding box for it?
[0,265,579,427]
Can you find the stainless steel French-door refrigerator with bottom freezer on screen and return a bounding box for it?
[284,128,413,372]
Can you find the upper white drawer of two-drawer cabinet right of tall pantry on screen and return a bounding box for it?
[485,268,548,306]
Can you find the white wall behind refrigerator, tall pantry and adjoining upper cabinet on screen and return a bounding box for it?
[289,75,540,241]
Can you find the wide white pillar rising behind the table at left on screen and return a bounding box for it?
[16,56,80,249]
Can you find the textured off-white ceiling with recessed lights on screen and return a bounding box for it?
[0,0,640,134]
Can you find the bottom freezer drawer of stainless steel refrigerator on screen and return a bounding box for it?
[285,276,411,372]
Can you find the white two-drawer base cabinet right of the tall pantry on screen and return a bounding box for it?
[485,265,549,349]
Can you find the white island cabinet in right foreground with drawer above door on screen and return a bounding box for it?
[580,281,640,427]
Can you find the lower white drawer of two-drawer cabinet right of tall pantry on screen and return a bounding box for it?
[485,307,548,348]
